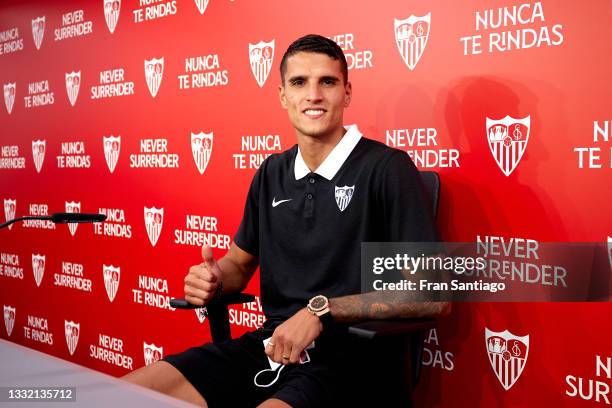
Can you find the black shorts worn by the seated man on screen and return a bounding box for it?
[163,325,355,408]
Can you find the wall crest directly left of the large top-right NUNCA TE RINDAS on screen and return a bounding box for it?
[395,13,431,71]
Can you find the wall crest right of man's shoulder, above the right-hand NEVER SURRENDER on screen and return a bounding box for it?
[487,116,530,176]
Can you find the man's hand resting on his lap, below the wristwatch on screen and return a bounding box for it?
[266,308,323,365]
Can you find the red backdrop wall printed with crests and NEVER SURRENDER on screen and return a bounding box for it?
[0,0,612,406]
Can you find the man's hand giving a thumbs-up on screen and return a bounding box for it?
[185,245,221,306]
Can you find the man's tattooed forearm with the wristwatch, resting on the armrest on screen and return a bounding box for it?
[329,291,450,323]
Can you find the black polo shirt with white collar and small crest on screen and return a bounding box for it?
[234,125,436,320]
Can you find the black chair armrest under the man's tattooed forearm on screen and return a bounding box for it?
[349,319,436,340]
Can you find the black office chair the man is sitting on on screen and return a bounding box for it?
[170,171,440,408]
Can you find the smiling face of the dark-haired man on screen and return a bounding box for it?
[279,52,351,138]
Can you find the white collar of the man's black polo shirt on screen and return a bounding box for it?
[294,125,361,180]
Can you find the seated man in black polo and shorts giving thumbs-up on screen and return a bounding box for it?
[126,35,446,407]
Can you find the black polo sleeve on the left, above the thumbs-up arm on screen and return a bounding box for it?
[234,165,264,257]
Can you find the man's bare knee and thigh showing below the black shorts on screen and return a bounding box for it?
[122,361,208,407]
